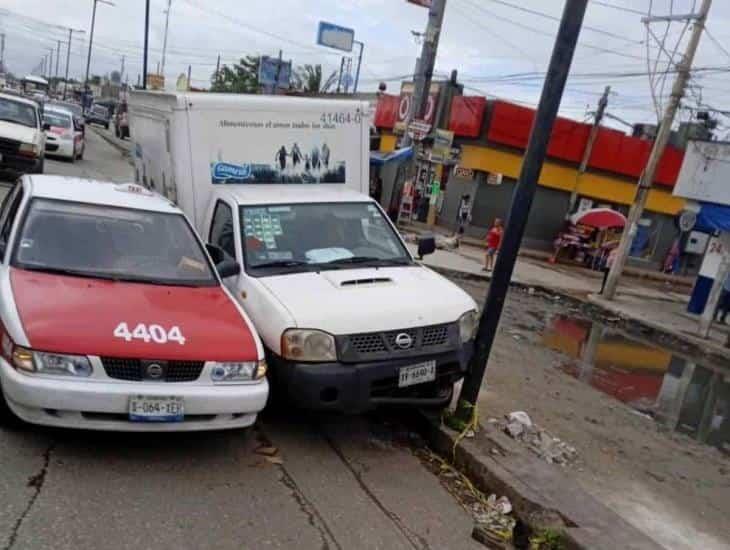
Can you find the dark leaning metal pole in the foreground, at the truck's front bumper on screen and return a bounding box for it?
[456,0,588,423]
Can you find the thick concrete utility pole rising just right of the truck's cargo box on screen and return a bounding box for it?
[403,0,446,148]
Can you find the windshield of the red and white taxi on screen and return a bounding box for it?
[13,199,217,286]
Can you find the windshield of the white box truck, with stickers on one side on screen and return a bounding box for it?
[240,202,412,272]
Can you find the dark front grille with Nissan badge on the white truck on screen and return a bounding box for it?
[337,323,459,362]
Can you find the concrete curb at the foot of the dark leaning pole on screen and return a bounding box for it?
[418,413,663,550]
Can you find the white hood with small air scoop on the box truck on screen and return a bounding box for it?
[260,266,476,335]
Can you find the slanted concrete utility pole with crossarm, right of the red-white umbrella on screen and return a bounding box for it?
[603,0,712,300]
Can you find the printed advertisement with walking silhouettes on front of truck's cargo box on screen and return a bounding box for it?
[198,110,363,184]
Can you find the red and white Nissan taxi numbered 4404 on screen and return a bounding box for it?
[0,176,268,431]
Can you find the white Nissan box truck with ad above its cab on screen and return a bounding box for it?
[129,92,477,412]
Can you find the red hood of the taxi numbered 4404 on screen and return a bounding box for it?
[10,268,258,361]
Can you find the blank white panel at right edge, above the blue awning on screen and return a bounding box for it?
[674,141,730,206]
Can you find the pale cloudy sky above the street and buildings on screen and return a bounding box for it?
[0,0,730,135]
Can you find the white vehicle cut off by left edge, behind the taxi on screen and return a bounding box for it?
[0,93,46,174]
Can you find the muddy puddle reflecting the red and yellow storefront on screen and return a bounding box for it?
[542,315,730,453]
